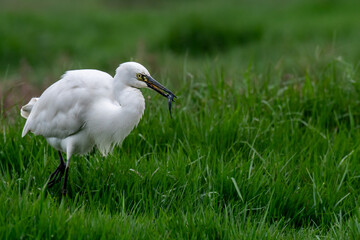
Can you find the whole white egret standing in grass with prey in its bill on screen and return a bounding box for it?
[21,62,176,194]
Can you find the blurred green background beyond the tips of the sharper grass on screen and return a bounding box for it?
[0,0,360,109]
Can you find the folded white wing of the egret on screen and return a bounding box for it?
[22,70,113,138]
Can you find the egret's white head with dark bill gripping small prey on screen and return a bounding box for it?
[115,62,176,116]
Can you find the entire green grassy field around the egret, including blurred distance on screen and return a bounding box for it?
[0,0,360,239]
